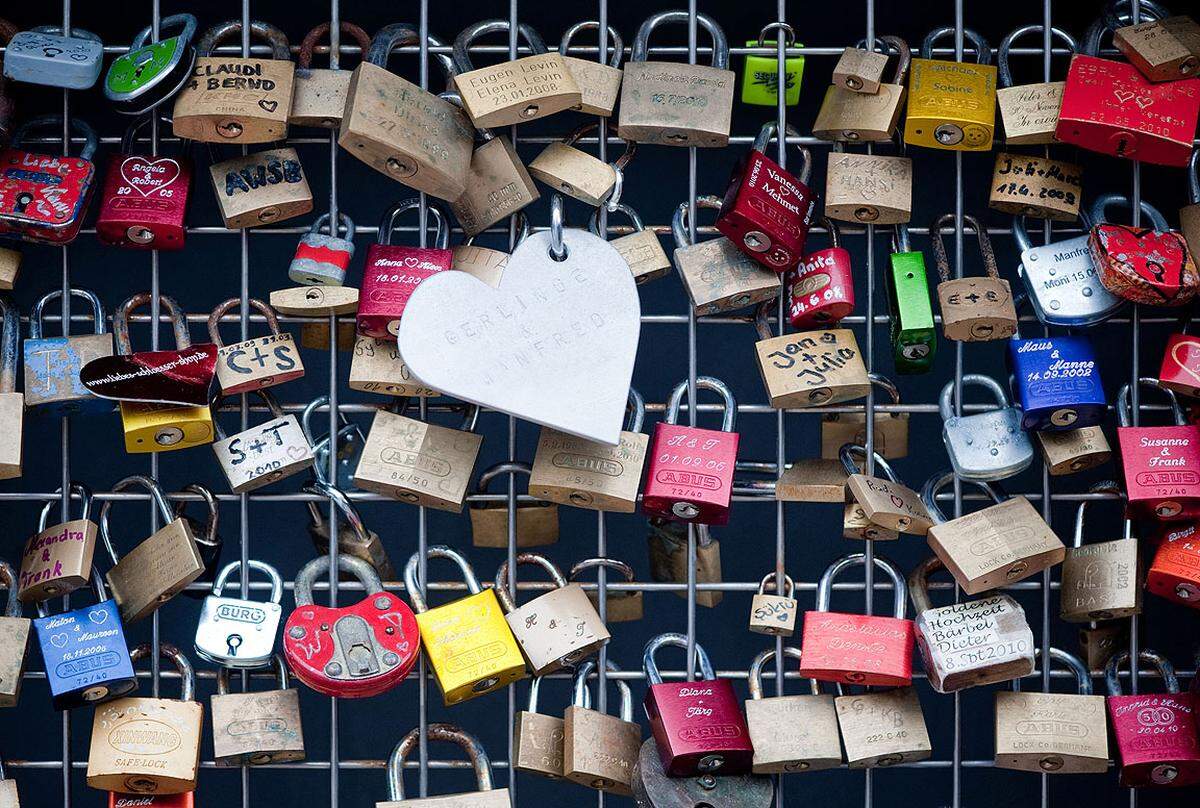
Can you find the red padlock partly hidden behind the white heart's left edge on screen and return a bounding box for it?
[356,197,454,340]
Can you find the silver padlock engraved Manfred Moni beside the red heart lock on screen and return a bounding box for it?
[1013,207,1123,327]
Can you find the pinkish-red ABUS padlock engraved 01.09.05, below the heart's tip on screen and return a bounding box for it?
[642,376,738,525]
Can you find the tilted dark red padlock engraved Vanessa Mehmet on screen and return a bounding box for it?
[716,121,817,273]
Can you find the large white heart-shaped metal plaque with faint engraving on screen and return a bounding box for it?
[397,229,642,445]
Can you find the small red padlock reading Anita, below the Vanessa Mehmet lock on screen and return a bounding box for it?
[787,216,854,330]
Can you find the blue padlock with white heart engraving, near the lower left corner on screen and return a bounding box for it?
[34,568,138,710]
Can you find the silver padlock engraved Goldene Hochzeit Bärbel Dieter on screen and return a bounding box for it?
[908,556,1036,693]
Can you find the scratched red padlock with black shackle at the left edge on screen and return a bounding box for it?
[0,115,98,245]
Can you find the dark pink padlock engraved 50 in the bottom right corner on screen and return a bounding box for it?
[1104,648,1200,788]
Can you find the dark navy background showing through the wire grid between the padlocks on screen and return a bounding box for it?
[0,0,1196,808]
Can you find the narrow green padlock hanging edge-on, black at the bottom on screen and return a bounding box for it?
[887,225,937,375]
